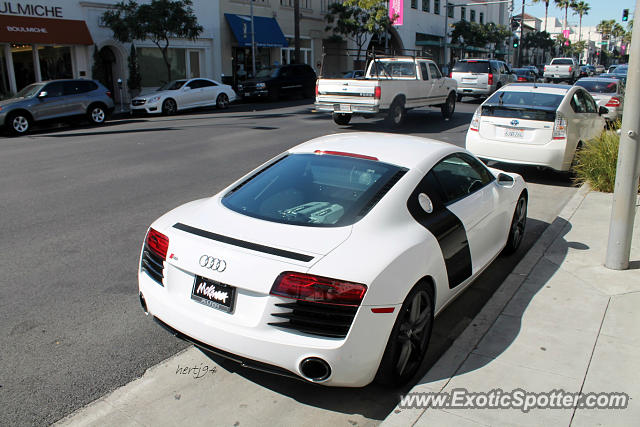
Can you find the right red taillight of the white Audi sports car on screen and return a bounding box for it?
[270,271,367,306]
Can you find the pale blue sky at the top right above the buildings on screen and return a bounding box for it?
[513,0,636,29]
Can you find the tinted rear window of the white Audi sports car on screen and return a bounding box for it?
[222,154,406,227]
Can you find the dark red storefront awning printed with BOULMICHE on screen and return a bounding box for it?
[0,15,93,45]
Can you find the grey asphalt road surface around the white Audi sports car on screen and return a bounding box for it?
[0,100,575,425]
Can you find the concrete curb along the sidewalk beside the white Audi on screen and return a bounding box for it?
[382,183,591,427]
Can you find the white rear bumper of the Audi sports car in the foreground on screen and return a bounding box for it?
[138,271,398,387]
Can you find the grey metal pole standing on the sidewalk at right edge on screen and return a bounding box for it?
[605,0,640,270]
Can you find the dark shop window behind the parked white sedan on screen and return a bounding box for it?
[138,47,187,87]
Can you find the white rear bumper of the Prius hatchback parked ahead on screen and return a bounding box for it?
[466,131,575,171]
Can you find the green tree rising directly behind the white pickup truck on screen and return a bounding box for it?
[325,0,392,61]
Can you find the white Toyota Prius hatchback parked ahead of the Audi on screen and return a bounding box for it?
[466,83,609,171]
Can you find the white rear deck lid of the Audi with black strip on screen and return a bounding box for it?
[159,196,352,267]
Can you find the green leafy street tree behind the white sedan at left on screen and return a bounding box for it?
[102,0,203,81]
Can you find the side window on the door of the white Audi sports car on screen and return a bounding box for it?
[431,153,494,203]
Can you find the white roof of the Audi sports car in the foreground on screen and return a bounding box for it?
[289,132,466,171]
